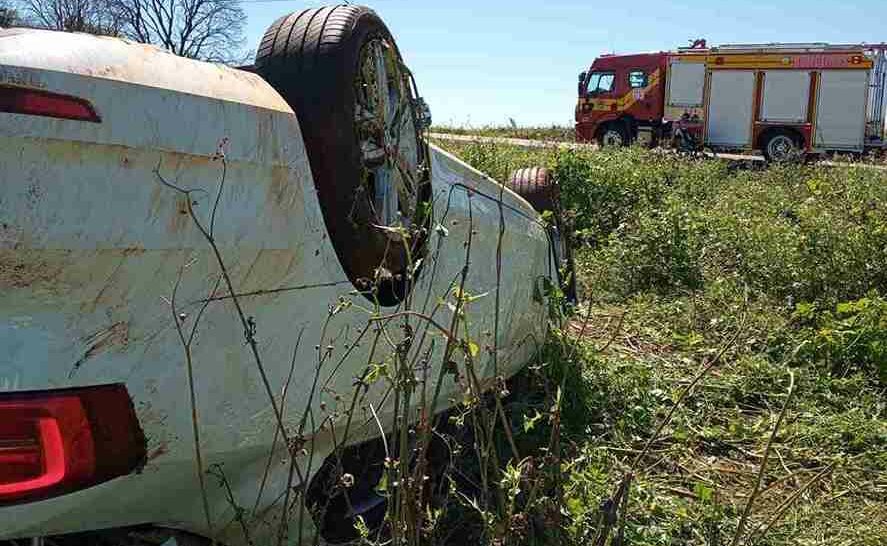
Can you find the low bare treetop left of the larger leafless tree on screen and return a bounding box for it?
[22,0,121,36]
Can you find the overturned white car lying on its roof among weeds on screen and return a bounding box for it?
[0,6,559,544]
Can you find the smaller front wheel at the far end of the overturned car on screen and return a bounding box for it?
[507,167,576,302]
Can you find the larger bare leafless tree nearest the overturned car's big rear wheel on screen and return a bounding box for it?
[110,0,246,63]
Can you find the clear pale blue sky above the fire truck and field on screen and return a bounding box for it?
[244,0,887,126]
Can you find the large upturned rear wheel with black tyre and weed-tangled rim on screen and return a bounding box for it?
[255,5,431,305]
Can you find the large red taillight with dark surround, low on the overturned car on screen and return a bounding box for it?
[0,385,145,505]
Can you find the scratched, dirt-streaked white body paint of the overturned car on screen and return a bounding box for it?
[0,31,553,544]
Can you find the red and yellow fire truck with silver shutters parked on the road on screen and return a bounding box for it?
[575,40,887,161]
